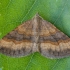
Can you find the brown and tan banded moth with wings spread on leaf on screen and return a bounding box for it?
[0,14,70,58]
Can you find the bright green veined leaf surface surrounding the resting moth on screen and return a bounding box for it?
[0,0,70,70]
